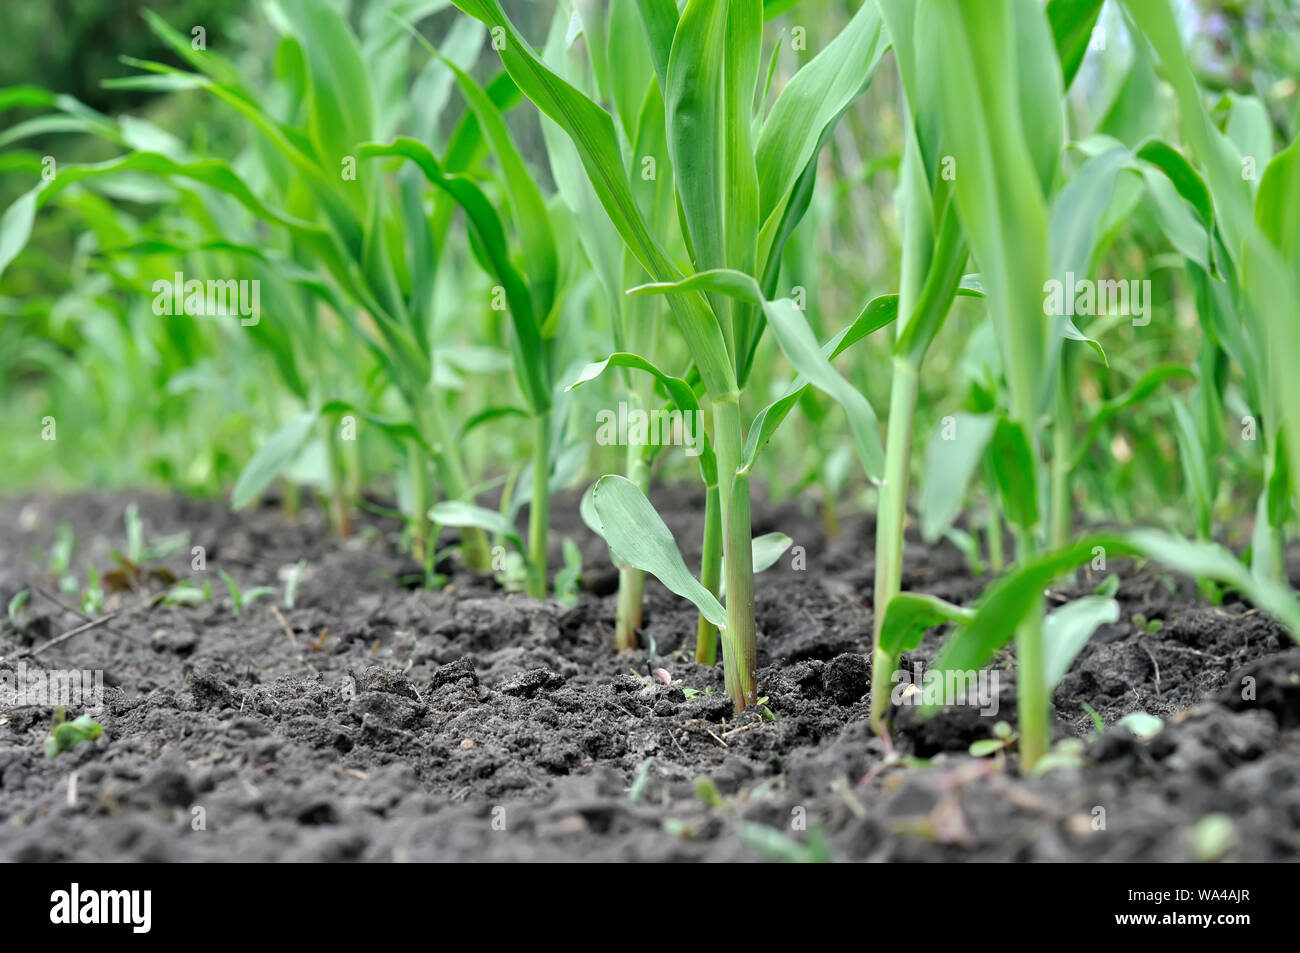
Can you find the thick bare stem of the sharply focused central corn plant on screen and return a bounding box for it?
[714,393,758,714]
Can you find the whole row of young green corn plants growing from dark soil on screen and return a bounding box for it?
[0,0,1300,766]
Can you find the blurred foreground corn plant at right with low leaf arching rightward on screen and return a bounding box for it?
[874,0,1300,768]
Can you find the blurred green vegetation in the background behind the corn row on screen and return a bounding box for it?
[0,0,1300,551]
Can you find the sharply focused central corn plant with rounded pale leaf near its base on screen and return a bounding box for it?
[456,0,883,710]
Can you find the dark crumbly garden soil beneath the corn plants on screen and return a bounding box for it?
[0,489,1300,862]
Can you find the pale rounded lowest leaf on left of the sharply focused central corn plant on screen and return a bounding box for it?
[592,476,727,629]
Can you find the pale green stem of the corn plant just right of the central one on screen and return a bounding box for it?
[871,358,918,733]
